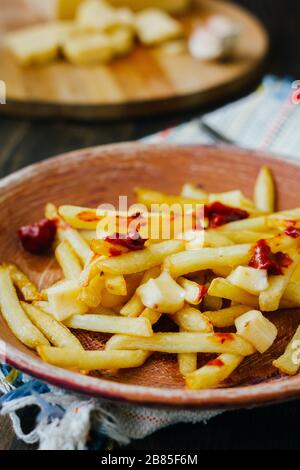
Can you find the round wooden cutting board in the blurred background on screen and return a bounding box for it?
[0,0,268,119]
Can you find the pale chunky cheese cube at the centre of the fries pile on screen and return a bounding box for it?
[137,271,185,313]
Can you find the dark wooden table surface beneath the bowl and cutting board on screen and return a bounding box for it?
[0,0,300,450]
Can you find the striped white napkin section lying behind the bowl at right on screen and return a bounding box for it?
[144,76,300,159]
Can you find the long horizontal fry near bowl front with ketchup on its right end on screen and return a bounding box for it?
[106,333,255,356]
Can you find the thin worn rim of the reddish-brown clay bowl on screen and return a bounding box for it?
[0,142,300,409]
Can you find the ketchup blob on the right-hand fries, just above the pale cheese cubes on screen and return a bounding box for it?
[249,240,293,276]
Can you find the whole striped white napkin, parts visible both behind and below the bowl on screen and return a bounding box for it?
[0,76,300,450]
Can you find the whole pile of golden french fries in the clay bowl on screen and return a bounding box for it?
[0,167,300,390]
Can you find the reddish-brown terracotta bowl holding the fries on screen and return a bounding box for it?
[0,144,300,408]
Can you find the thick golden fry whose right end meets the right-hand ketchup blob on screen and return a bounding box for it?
[164,244,252,278]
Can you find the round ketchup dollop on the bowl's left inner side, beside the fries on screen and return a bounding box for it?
[18,219,57,255]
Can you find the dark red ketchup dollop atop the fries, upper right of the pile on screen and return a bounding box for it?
[204,202,249,228]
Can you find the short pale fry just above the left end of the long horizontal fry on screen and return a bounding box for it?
[65,314,153,336]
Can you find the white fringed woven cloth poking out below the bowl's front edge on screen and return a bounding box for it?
[1,387,221,450]
